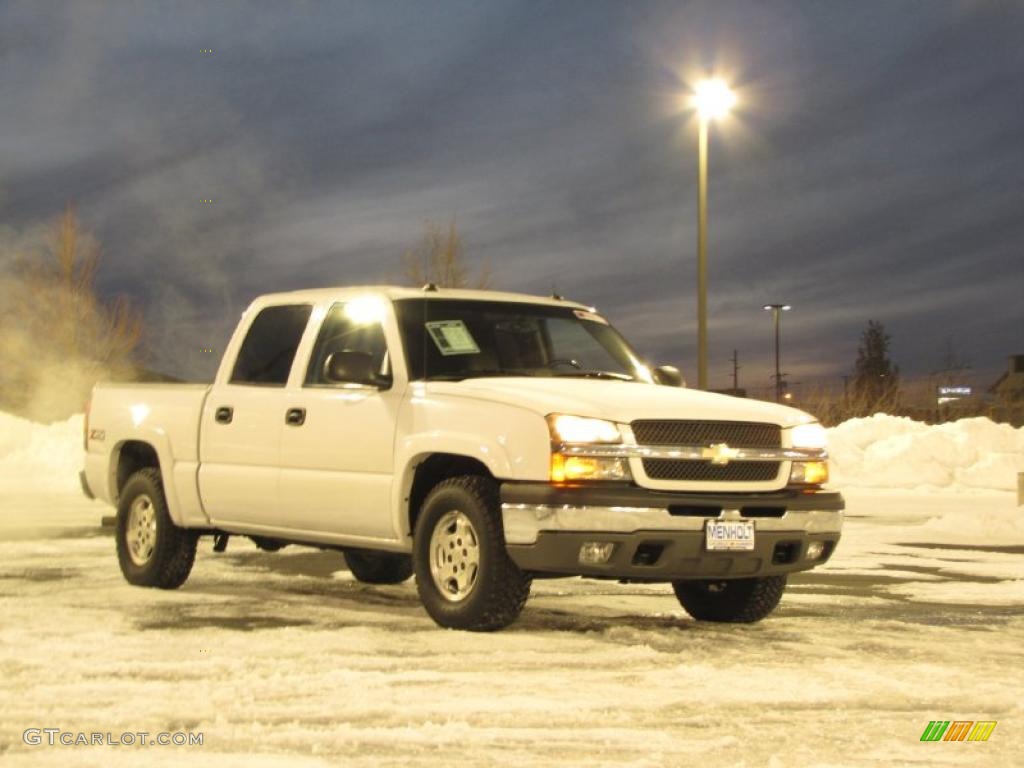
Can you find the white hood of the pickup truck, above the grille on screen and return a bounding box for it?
[427,377,815,434]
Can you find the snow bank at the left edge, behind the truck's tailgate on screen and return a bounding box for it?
[0,412,84,490]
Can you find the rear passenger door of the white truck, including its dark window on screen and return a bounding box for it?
[199,304,312,529]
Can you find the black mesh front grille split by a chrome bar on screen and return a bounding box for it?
[630,420,782,482]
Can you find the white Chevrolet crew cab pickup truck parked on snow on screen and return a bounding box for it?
[83,286,844,630]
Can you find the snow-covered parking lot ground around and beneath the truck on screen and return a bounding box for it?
[0,415,1024,766]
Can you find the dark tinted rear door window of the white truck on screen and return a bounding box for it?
[231,304,312,387]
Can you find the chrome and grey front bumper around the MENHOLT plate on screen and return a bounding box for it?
[502,482,845,581]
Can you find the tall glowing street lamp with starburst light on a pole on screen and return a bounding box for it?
[692,79,736,389]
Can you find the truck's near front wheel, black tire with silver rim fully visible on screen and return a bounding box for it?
[413,475,532,632]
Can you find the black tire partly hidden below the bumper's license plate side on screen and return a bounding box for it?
[672,575,785,624]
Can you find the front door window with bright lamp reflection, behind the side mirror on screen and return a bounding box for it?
[305,302,391,386]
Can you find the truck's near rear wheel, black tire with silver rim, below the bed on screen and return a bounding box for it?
[117,468,199,590]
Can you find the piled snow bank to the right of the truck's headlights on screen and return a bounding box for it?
[828,414,1024,490]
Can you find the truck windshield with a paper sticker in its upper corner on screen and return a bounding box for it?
[395,299,651,383]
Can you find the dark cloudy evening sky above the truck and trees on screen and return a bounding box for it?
[0,0,1024,389]
